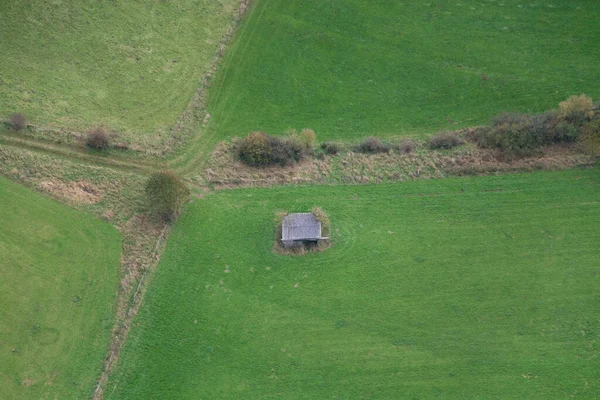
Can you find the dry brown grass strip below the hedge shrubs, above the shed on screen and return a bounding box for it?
[204,142,595,189]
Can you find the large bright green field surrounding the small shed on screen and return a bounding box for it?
[107,169,600,399]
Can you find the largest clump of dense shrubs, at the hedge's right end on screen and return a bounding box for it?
[467,95,600,157]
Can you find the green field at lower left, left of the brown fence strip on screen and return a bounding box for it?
[0,178,121,399]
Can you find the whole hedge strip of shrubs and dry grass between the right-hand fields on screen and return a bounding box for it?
[216,95,600,187]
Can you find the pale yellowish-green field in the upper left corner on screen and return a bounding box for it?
[0,0,236,134]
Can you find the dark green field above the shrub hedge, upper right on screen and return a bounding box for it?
[209,0,600,139]
